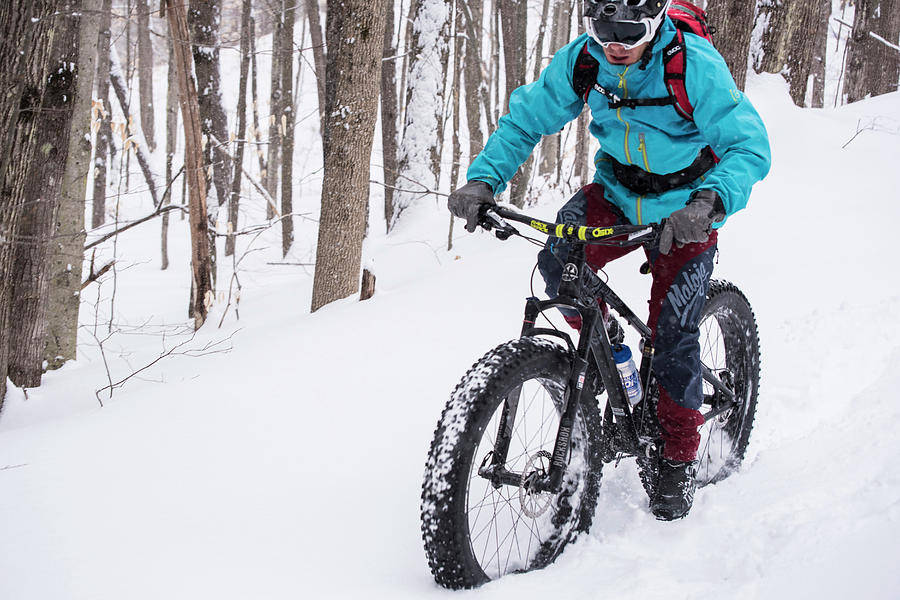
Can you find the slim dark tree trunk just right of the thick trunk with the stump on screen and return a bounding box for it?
[381,0,397,228]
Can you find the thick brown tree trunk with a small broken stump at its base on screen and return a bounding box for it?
[312,0,385,311]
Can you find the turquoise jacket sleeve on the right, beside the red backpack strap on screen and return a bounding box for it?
[685,36,772,215]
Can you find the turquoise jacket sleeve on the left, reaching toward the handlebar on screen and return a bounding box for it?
[466,37,584,194]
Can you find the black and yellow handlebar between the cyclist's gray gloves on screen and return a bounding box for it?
[478,204,662,246]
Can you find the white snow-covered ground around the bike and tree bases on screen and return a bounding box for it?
[0,43,900,600]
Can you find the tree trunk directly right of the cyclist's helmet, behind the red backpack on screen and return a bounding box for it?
[706,0,756,90]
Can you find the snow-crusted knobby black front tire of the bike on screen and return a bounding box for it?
[421,337,602,589]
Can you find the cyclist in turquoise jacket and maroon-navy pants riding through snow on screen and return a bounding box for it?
[448,0,771,520]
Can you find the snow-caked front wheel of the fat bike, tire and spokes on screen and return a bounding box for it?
[422,337,602,589]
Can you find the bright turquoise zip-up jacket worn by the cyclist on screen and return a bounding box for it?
[466,19,771,225]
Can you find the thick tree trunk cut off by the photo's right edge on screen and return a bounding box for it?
[844,0,900,102]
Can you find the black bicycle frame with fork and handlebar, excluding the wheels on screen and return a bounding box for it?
[478,208,736,493]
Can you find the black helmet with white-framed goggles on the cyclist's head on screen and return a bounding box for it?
[584,0,671,49]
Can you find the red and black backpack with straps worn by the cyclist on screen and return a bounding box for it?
[572,0,715,121]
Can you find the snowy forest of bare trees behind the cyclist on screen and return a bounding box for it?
[0,0,900,426]
